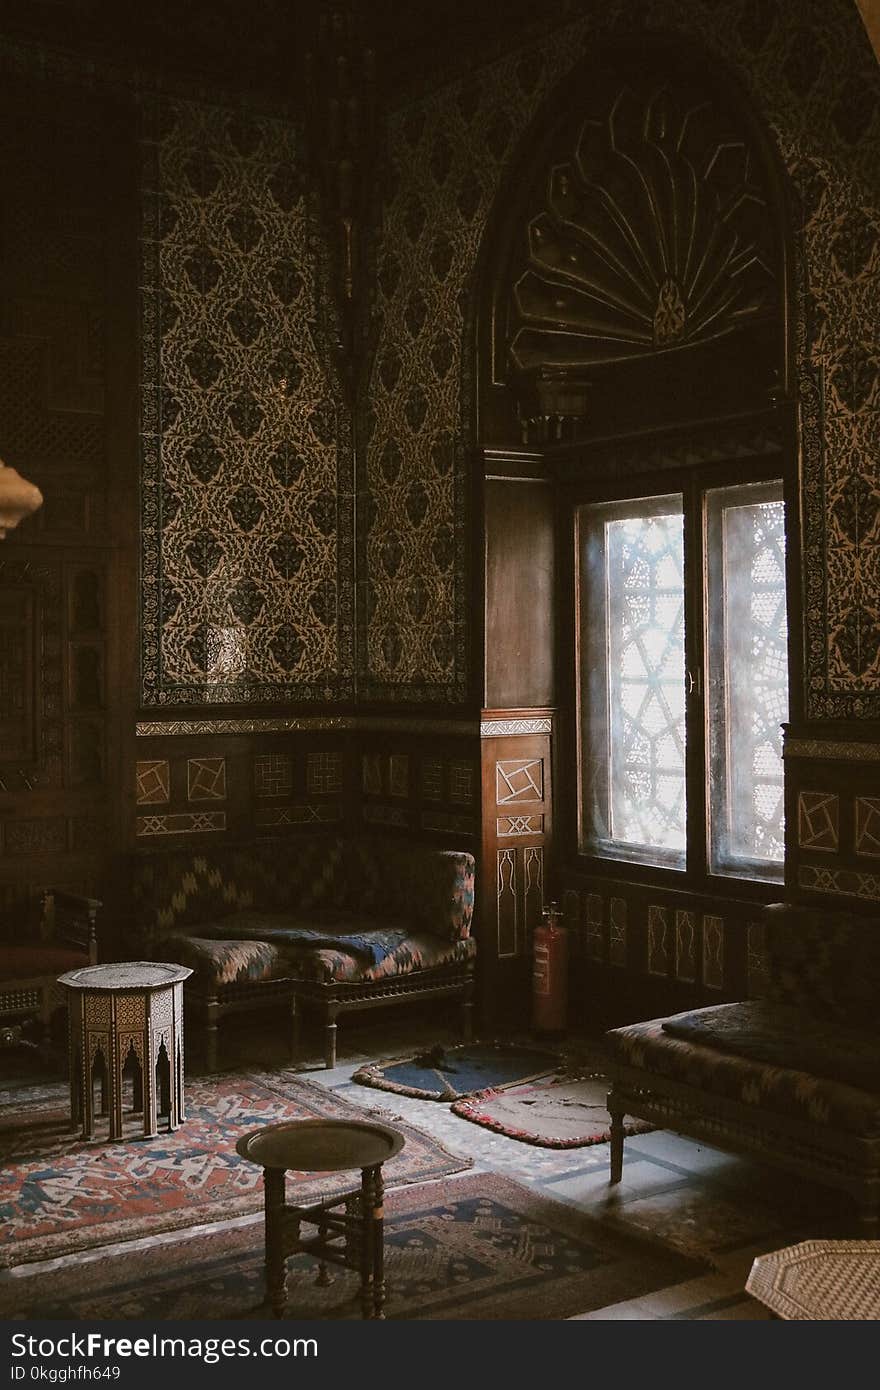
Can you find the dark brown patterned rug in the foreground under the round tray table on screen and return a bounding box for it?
[0,1173,706,1321]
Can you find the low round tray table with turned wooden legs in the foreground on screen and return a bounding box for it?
[235,1119,405,1318]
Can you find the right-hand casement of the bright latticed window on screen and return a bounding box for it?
[706,484,788,878]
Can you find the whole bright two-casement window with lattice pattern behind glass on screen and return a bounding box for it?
[576,482,788,881]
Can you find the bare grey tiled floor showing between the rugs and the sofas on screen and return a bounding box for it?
[0,1023,851,1321]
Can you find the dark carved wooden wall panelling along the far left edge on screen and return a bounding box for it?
[0,76,124,935]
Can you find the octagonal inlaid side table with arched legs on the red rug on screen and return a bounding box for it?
[58,960,192,1140]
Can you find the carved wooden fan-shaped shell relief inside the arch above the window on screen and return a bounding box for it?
[509,82,776,373]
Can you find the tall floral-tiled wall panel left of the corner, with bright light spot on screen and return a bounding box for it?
[142,99,353,705]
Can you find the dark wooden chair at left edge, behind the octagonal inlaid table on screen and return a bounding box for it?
[0,888,101,1052]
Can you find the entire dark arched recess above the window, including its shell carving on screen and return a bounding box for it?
[482,51,787,443]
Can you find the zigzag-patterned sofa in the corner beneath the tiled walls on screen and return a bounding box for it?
[132,835,475,1070]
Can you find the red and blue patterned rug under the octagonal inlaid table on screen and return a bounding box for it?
[0,1072,471,1266]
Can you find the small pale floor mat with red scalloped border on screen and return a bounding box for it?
[452,1074,655,1148]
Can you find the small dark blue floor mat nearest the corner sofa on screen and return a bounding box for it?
[352,1043,562,1101]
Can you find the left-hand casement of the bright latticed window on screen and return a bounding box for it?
[580,496,687,867]
